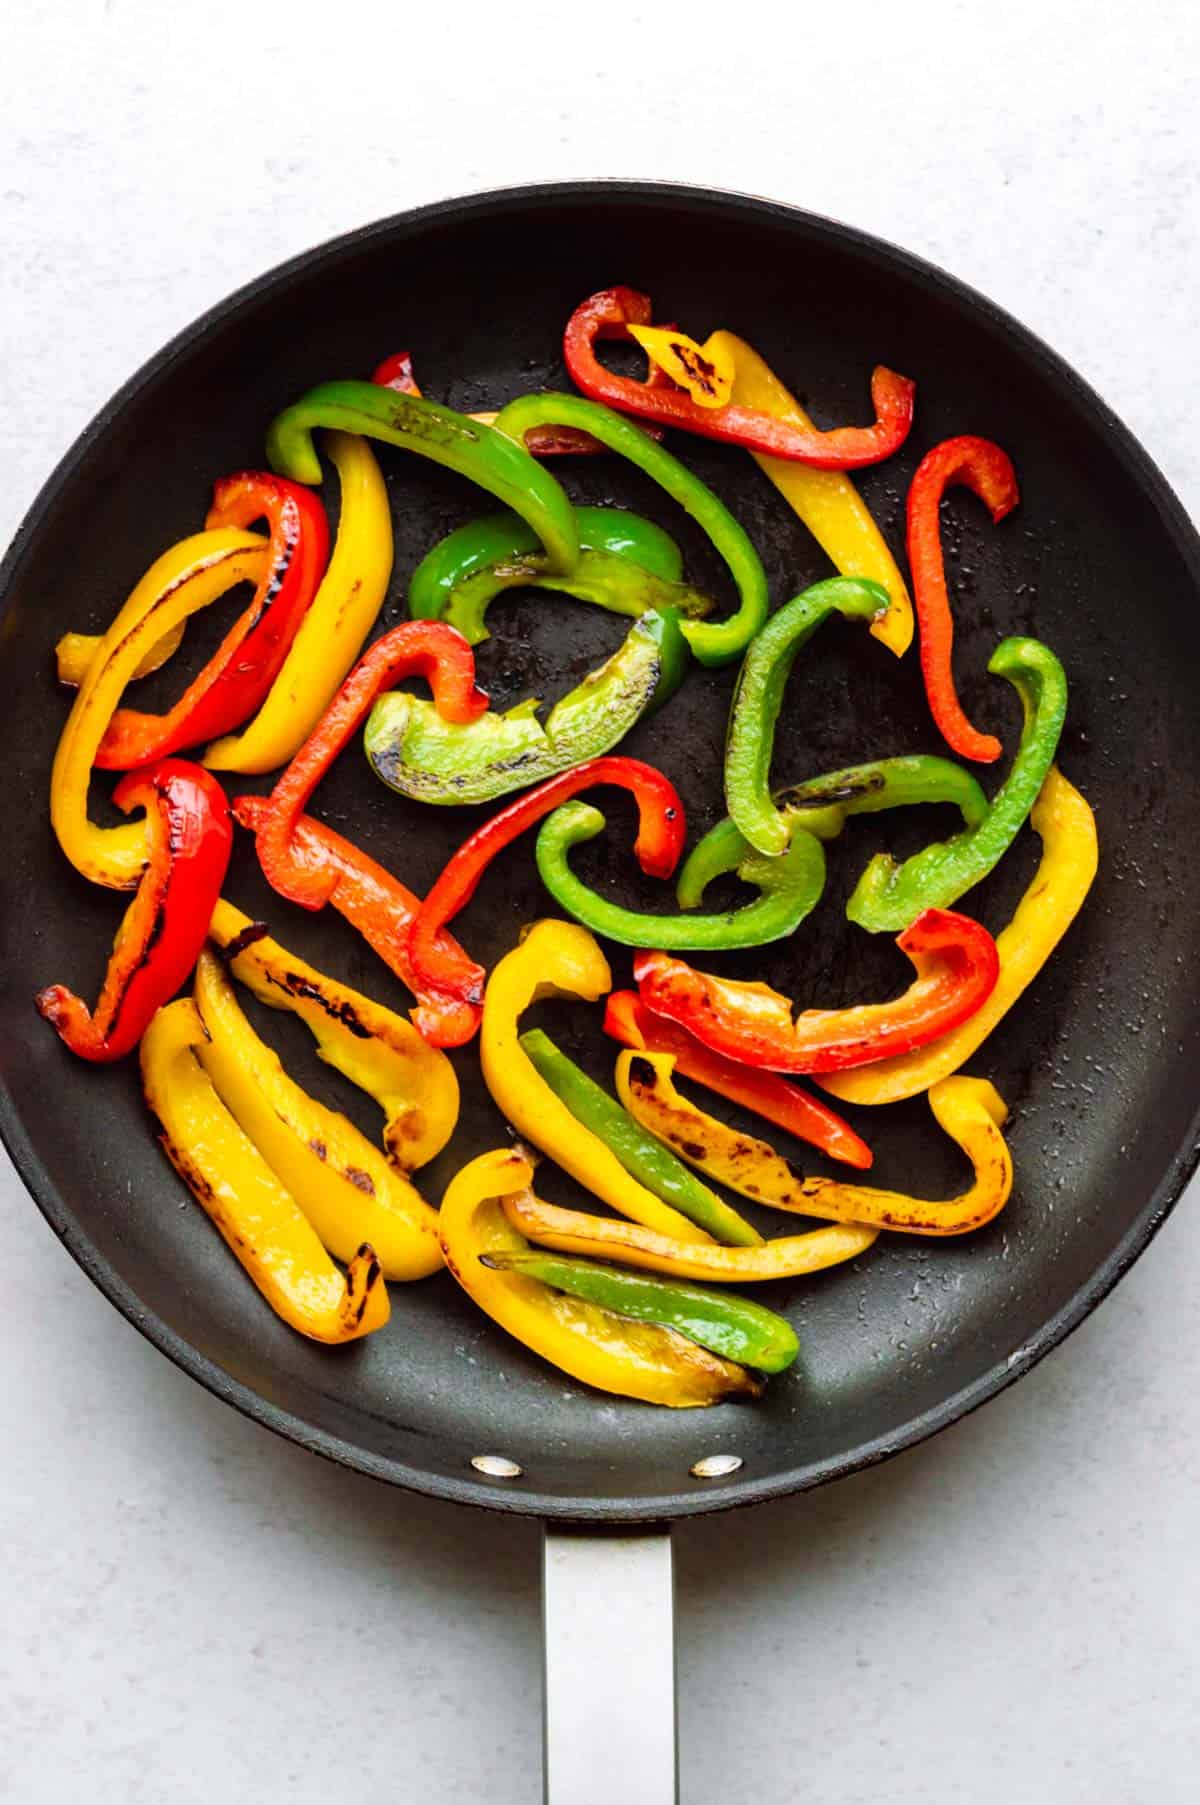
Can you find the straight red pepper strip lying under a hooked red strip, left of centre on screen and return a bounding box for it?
[233,796,480,1047]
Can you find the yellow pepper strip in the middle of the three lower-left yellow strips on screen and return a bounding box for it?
[195,951,442,1280]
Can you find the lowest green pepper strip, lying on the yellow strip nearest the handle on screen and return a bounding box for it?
[478,1247,799,1372]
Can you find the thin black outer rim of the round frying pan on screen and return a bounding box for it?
[0,179,1200,1523]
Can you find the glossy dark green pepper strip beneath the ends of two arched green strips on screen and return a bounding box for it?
[408,507,713,646]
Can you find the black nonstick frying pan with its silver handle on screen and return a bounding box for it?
[0,182,1200,1805]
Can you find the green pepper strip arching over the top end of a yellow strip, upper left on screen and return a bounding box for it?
[267,381,579,570]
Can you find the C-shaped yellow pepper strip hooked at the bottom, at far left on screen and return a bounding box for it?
[51,527,267,890]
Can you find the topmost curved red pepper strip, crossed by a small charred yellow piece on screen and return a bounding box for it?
[563,287,917,469]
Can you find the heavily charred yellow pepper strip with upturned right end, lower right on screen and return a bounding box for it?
[617,1052,1012,1235]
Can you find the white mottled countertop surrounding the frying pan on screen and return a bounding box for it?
[0,0,1200,1805]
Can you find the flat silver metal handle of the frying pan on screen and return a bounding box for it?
[541,1523,678,1805]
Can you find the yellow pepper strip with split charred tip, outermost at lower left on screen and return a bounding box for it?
[141,998,390,1343]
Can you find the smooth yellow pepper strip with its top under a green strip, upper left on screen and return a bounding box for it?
[204,433,392,773]
